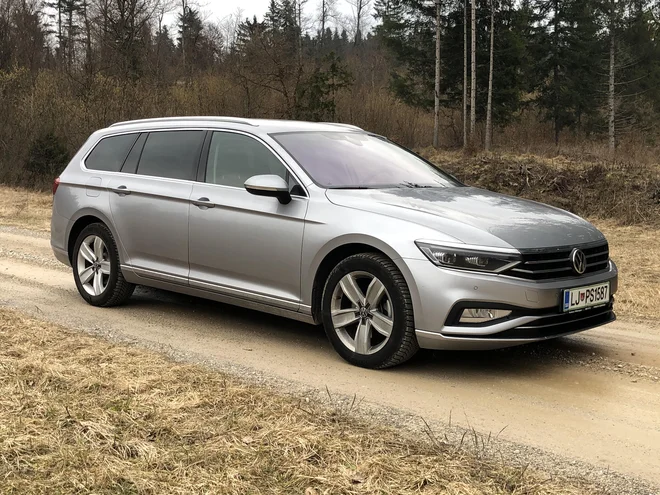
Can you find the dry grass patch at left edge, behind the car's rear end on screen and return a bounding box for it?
[0,186,53,232]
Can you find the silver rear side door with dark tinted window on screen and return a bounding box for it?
[109,130,206,285]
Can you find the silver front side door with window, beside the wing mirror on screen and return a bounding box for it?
[190,131,308,310]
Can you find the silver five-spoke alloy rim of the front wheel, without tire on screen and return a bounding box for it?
[330,271,394,355]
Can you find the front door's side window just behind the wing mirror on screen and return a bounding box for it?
[205,132,288,187]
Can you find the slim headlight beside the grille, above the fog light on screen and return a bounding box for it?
[415,241,522,273]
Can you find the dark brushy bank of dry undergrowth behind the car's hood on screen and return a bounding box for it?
[421,148,660,228]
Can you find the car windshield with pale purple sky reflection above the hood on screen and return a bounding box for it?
[272,132,461,189]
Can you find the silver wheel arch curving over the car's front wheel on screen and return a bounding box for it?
[309,235,420,324]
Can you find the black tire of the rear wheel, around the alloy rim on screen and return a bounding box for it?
[71,223,135,308]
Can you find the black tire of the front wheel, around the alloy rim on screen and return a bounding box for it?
[321,253,419,369]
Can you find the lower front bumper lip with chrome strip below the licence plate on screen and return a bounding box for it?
[416,301,616,350]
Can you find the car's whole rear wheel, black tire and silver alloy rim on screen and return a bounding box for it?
[71,223,135,307]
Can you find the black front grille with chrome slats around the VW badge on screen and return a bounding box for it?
[504,242,610,280]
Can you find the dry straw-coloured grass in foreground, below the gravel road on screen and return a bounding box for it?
[0,309,593,495]
